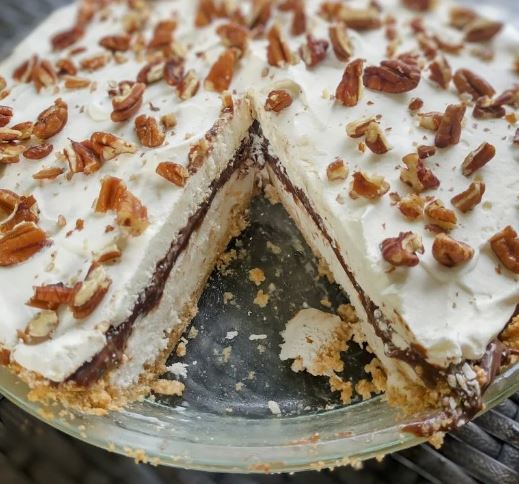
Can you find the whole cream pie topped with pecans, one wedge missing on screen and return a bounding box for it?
[0,0,519,432]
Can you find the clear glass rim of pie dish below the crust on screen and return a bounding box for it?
[0,364,519,473]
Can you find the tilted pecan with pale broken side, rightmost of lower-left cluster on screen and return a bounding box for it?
[70,265,112,319]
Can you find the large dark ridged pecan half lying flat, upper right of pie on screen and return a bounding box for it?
[364,60,421,94]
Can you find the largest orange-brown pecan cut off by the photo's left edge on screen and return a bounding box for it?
[0,222,48,267]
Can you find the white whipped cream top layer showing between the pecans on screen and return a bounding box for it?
[0,0,519,381]
